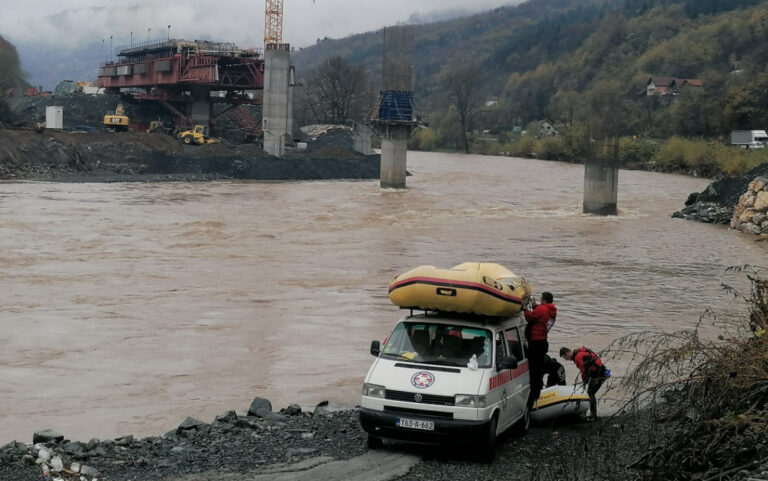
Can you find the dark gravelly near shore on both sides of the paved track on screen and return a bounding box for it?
[0,398,656,481]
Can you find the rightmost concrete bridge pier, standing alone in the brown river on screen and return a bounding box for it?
[583,140,619,215]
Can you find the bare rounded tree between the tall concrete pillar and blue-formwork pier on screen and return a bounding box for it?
[304,55,368,124]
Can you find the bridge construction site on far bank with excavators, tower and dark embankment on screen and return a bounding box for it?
[0,0,390,182]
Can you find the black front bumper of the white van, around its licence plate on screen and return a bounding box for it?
[360,408,491,444]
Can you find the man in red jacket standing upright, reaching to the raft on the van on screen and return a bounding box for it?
[523,292,557,409]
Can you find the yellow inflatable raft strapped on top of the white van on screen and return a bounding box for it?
[389,262,531,317]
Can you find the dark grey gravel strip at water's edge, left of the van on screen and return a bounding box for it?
[0,398,366,481]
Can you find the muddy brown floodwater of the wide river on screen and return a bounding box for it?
[0,152,768,444]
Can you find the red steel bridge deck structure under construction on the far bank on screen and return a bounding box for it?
[98,39,264,129]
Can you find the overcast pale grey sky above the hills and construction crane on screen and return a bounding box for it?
[0,0,520,47]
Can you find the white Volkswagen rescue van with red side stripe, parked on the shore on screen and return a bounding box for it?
[360,311,531,460]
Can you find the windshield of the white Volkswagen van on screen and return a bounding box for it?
[381,322,491,368]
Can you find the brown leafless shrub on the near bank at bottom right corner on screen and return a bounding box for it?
[604,267,768,480]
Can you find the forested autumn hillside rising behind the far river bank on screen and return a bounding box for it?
[294,0,768,142]
